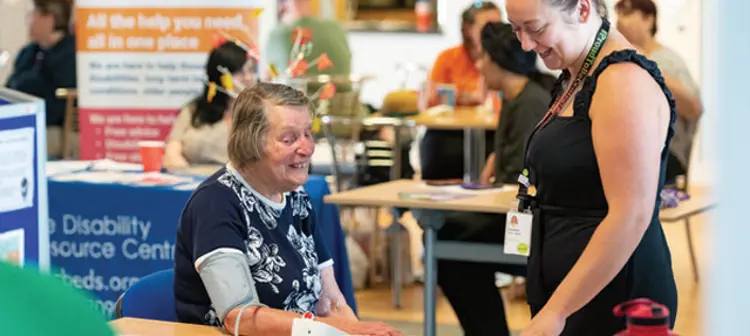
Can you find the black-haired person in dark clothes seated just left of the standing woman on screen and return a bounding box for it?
[438,22,551,336]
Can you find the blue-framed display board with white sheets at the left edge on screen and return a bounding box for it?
[0,88,49,271]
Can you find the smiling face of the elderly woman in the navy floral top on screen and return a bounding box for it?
[258,106,315,191]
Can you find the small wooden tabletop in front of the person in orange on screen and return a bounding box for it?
[408,107,498,130]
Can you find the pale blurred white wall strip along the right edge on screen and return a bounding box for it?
[703,0,750,335]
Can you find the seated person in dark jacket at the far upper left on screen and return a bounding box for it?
[5,0,76,158]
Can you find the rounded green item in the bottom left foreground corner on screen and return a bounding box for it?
[0,261,115,336]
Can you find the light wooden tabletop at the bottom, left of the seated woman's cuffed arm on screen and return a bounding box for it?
[109,317,226,336]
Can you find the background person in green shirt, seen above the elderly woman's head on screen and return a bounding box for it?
[264,0,352,84]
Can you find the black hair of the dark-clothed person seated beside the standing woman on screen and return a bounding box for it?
[481,22,556,90]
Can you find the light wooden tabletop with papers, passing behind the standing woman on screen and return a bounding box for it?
[324,180,716,222]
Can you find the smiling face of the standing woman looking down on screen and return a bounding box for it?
[506,0,585,70]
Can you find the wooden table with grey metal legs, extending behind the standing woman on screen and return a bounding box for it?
[324,180,716,336]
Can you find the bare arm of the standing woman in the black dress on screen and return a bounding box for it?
[542,63,669,318]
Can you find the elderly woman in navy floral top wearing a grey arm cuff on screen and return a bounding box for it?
[174,83,399,336]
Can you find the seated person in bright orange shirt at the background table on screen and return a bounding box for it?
[419,2,500,180]
